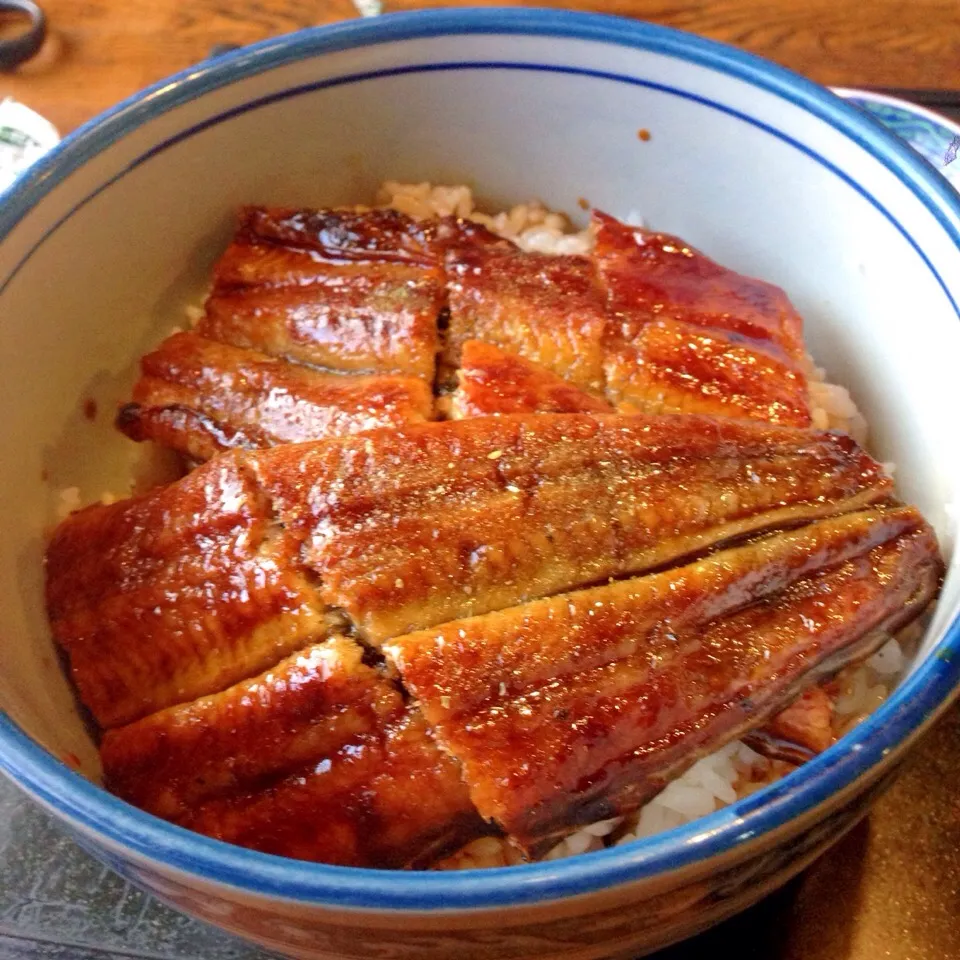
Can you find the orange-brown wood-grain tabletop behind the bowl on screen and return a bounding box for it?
[0,0,960,133]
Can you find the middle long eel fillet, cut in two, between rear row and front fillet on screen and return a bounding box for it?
[46,414,891,727]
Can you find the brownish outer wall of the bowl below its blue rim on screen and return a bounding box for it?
[37,769,896,960]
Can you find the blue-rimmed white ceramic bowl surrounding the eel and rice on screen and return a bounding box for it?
[0,9,960,960]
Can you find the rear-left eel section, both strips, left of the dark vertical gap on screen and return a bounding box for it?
[117,207,510,462]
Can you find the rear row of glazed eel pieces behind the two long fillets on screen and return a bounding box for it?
[118,207,810,461]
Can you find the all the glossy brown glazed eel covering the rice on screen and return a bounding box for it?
[39,207,942,867]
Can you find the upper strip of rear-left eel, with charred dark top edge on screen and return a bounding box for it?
[197,207,512,384]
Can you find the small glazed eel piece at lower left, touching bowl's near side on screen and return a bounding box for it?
[100,636,488,867]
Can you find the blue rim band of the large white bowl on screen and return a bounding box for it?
[0,8,960,908]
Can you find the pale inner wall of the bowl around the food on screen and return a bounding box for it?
[0,13,960,840]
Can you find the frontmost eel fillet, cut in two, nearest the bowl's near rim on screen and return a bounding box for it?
[92,508,940,866]
